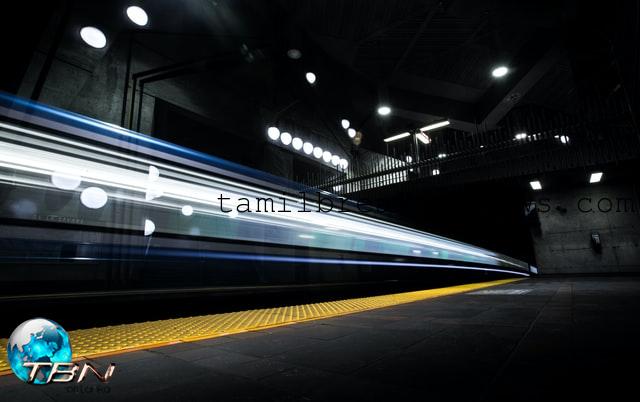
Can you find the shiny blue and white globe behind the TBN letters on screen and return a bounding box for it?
[7,318,71,384]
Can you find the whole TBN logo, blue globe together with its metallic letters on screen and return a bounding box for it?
[7,318,116,384]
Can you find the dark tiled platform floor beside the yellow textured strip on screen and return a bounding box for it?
[0,277,640,401]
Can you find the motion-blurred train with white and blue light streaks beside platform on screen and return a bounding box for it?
[0,94,531,296]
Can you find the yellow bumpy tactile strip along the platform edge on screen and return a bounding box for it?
[0,279,520,375]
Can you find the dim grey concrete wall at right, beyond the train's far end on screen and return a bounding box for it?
[532,183,640,274]
